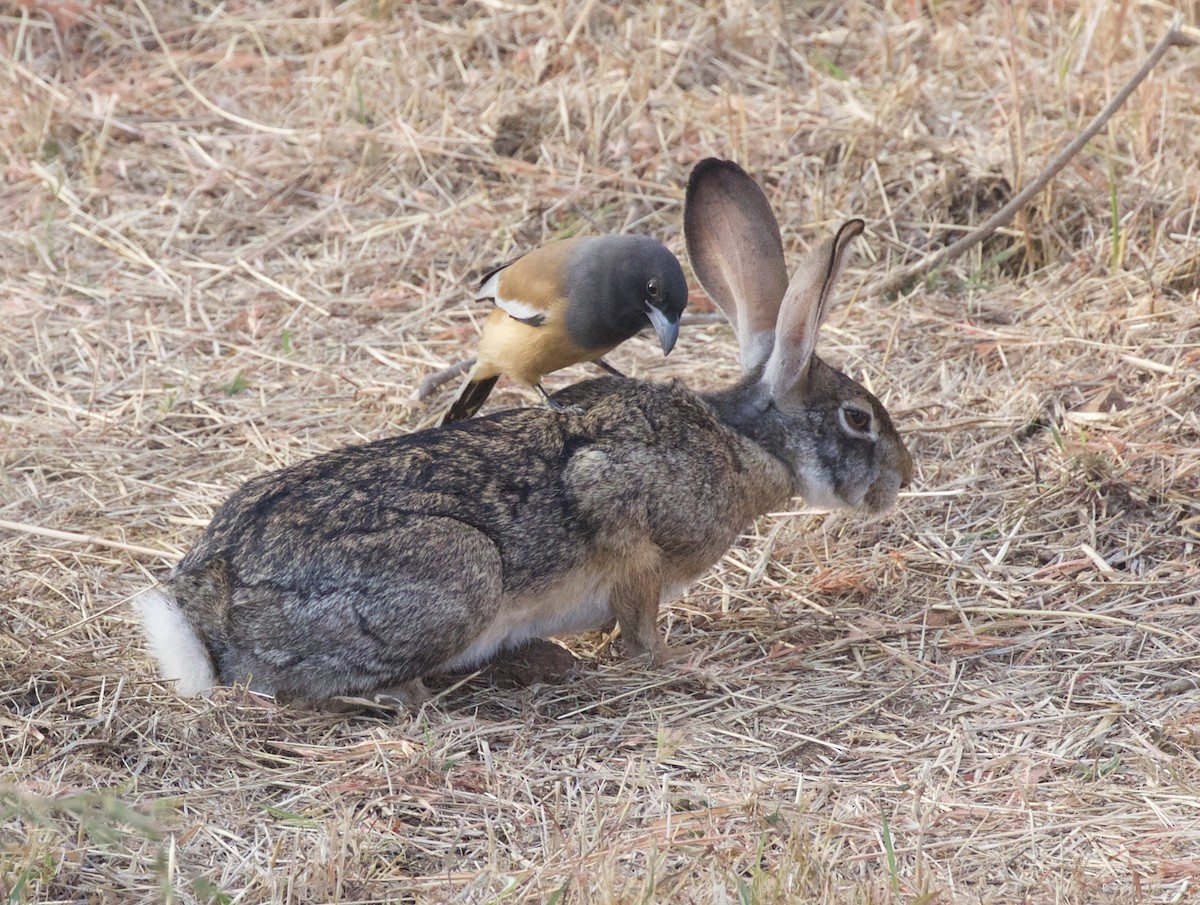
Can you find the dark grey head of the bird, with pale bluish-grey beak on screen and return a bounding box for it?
[566,235,688,354]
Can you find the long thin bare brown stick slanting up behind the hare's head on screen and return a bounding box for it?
[875,14,1196,295]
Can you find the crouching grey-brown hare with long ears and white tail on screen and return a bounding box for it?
[139,158,912,703]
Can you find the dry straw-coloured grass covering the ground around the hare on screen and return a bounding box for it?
[0,0,1200,905]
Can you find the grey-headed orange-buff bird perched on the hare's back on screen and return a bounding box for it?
[440,235,688,424]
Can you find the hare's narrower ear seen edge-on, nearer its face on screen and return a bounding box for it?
[762,220,864,398]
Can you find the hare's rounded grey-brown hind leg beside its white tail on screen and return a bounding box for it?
[222,516,503,700]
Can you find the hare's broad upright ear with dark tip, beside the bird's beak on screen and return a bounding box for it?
[683,157,787,373]
